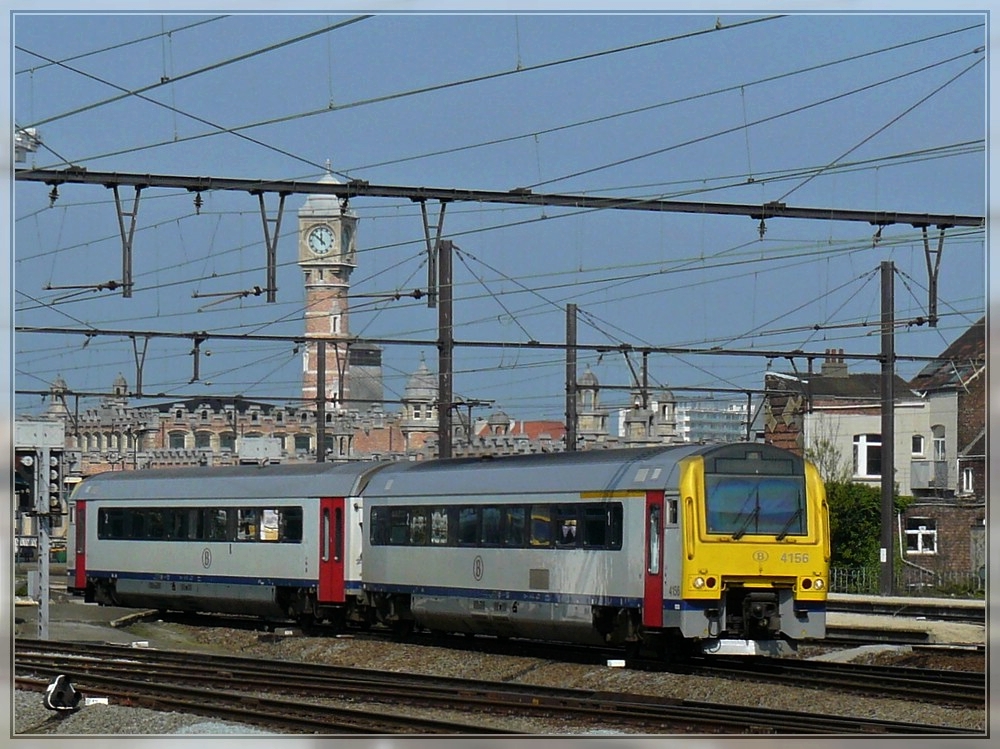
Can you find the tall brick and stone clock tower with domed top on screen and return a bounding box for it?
[299,173,358,408]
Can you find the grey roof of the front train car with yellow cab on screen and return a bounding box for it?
[364,442,802,498]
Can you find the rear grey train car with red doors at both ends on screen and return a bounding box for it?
[67,464,372,623]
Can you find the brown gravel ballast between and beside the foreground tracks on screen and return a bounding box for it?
[13,622,986,735]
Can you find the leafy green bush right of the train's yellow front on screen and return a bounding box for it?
[826,481,911,570]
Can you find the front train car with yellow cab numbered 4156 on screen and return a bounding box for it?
[363,443,830,654]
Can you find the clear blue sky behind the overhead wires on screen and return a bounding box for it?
[9,4,987,420]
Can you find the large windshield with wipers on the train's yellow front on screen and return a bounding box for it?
[705,474,806,541]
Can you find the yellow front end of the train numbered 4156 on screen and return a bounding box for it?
[660,443,830,655]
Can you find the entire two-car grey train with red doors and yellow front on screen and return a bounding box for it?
[67,442,830,655]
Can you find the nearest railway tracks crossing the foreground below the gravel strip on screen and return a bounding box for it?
[15,640,977,735]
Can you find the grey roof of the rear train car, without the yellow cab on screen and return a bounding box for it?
[73,462,385,500]
